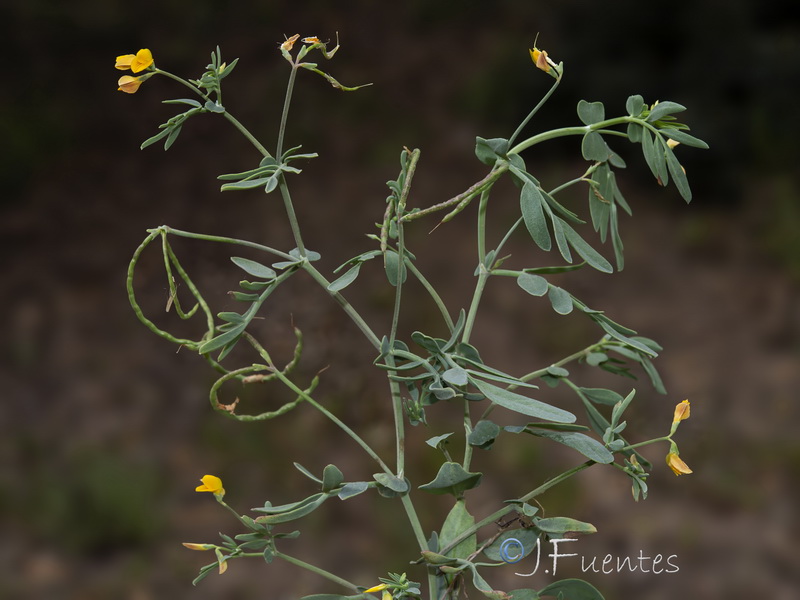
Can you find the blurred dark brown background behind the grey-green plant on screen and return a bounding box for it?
[0,0,800,600]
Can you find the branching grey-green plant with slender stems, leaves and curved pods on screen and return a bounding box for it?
[120,36,706,600]
